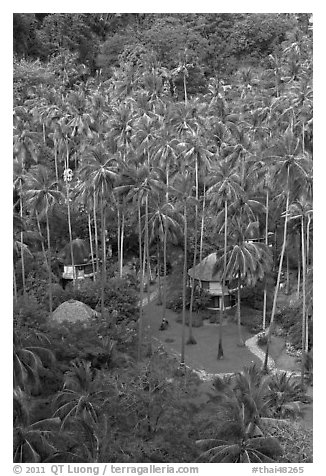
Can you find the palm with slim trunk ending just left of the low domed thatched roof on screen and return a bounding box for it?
[26,165,62,316]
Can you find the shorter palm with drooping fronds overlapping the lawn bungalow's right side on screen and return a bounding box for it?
[216,217,272,346]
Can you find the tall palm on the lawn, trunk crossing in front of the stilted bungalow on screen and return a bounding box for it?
[207,161,242,359]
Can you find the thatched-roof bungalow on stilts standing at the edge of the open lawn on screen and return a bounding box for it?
[188,253,235,309]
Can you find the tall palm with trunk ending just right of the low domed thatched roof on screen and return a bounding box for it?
[80,145,118,316]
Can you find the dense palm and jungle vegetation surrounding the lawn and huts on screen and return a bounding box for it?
[13,13,313,462]
